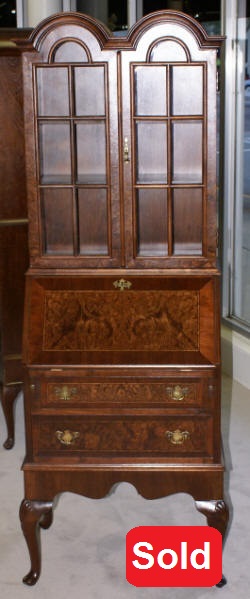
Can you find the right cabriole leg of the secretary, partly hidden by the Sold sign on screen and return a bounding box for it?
[195,499,229,588]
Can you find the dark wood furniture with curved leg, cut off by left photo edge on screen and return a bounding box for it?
[0,45,28,449]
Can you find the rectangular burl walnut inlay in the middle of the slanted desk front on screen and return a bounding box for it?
[43,290,199,351]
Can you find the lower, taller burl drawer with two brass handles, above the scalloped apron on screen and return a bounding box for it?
[33,414,213,458]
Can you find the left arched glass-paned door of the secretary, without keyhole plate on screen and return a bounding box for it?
[25,25,120,268]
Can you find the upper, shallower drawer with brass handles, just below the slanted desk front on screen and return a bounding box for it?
[30,376,216,410]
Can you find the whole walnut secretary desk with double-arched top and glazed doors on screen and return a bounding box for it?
[16,11,228,585]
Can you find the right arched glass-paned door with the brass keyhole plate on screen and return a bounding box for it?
[122,18,219,268]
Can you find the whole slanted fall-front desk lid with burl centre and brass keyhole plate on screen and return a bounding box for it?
[24,272,219,367]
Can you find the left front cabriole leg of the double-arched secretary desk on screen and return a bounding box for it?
[20,499,53,586]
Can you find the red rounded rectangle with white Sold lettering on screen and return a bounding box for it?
[126,526,222,587]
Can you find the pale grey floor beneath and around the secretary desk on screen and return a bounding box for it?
[0,378,250,599]
